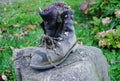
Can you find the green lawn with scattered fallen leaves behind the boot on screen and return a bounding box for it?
[0,0,120,81]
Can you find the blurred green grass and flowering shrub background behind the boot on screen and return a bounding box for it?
[0,0,120,81]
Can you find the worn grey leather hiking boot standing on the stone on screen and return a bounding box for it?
[30,2,77,70]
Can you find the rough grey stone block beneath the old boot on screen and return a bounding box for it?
[13,46,110,81]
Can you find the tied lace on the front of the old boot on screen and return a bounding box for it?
[40,34,62,67]
